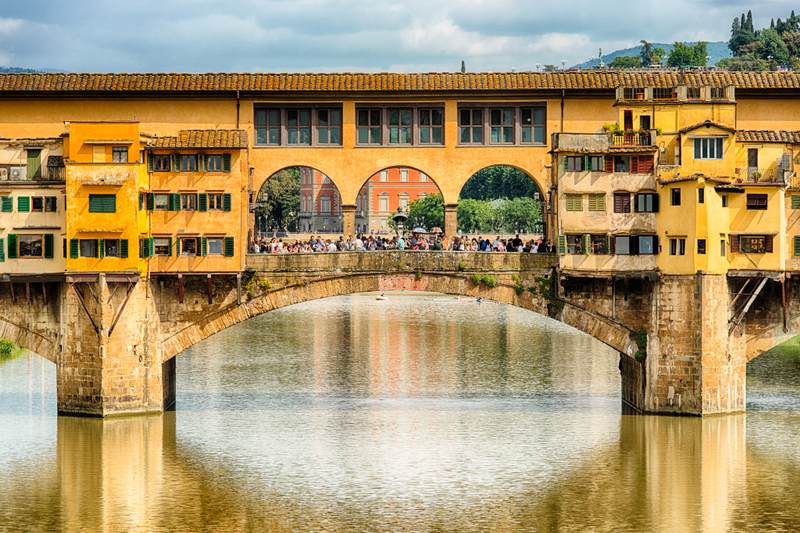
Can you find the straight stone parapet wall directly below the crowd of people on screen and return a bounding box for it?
[247,250,558,274]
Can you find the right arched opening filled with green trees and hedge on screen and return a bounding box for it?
[456,165,546,240]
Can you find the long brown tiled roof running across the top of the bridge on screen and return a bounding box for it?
[0,70,800,93]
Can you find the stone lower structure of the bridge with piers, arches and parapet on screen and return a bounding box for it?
[0,251,800,416]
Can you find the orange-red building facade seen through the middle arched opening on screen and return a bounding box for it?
[355,165,443,233]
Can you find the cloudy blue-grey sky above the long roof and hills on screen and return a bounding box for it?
[0,0,800,72]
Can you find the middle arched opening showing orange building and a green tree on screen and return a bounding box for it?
[356,166,444,234]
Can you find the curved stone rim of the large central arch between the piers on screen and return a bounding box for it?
[161,272,636,362]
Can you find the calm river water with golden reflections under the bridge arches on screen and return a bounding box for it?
[0,293,800,532]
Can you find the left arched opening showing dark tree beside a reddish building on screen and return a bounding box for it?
[255,166,343,238]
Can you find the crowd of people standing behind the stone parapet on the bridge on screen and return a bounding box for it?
[250,233,555,254]
